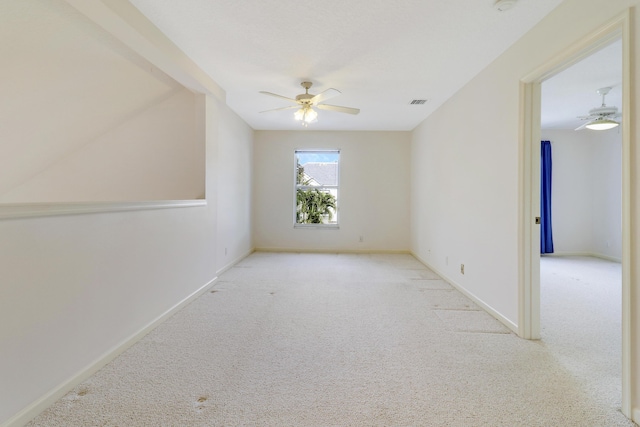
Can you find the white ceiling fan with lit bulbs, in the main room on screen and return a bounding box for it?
[260,82,360,126]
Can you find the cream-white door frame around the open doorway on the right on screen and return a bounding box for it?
[518,10,640,421]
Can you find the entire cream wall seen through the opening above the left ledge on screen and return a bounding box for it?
[0,0,205,203]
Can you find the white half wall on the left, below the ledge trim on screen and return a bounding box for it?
[0,202,216,423]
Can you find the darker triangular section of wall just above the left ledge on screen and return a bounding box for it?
[0,89,205,203]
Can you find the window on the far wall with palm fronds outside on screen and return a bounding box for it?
[294,150,340,227]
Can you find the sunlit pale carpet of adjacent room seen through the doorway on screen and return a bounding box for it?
[540,256,622,409]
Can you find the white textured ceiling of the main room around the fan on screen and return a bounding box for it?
[131,0,562,130]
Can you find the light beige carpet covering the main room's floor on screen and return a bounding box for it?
[30,253,633,427]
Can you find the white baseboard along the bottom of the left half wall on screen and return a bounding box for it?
[0,277,217,427]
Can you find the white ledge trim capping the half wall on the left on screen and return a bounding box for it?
[0,199,207,220]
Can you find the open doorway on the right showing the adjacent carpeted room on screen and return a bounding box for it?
[540,40,623,407]
